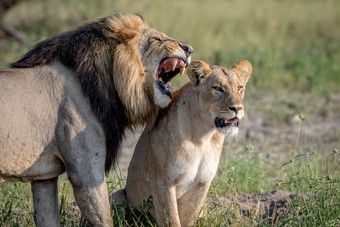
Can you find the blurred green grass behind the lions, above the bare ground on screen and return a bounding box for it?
[0,0,340,95]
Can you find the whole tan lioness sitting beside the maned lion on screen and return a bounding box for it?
[112,60,252,226]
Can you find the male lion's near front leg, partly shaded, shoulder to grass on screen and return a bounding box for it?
[57,105,113,226]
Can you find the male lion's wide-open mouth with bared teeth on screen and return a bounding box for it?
[157,58,187,98]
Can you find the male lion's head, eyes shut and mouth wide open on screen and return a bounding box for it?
[105,14,193,107]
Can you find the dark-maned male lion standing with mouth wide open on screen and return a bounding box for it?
[0,13,193,226]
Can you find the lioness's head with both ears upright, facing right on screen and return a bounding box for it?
[187,60,252,135]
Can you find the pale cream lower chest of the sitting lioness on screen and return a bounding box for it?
[172,143,220,198]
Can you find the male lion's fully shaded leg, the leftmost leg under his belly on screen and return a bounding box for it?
[31,177,60,227]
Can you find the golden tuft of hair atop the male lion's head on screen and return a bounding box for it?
[104,13,148,42]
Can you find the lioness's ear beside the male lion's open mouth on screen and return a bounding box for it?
[187,61,211,86]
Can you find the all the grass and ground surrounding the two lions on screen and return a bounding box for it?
[0,0,340,226]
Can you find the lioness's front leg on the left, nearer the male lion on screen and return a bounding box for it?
[151,182,181,227]
